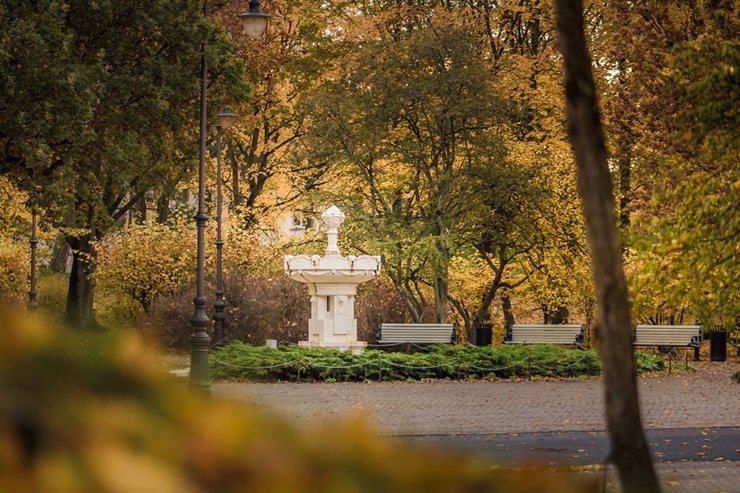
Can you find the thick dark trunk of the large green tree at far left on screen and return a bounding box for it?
[64,236,101,330]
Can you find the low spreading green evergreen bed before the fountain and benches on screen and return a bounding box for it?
[211,342,665,382]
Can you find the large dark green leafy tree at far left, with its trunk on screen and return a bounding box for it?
[0,0,247,325]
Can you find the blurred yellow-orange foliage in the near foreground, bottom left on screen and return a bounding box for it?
[0,315,597,493]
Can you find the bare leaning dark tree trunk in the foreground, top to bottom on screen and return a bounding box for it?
[556,0,660,493]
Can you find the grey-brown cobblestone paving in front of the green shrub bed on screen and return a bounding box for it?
[212,362,740,493]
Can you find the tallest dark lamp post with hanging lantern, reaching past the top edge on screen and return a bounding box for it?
[189,0,270,393]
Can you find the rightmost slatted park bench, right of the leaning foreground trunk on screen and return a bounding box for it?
[632,325,704,373]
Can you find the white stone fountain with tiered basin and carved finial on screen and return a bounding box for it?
[284,206,381,353]
